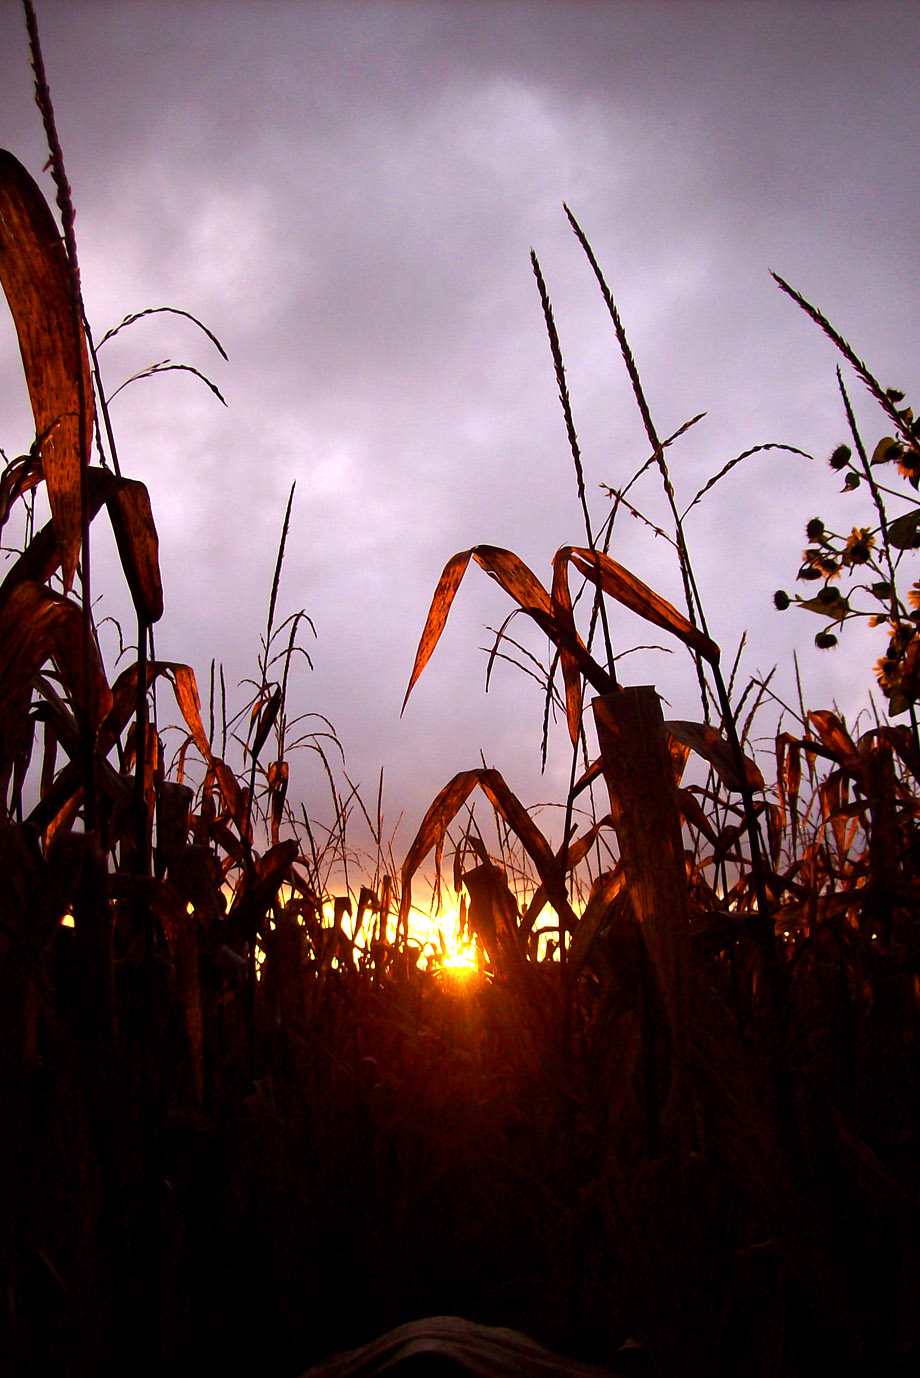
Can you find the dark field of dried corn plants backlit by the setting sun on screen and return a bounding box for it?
[0,0,920,1378]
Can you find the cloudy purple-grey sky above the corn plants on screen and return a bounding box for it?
[0,0,920,892]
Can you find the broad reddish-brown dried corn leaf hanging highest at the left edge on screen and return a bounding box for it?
[0,149,92,590]
